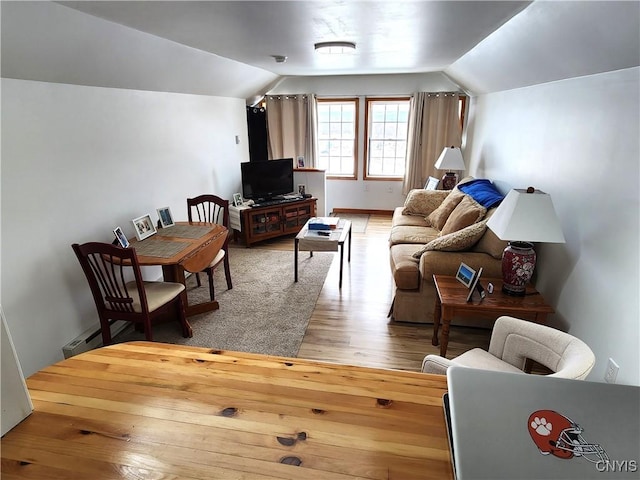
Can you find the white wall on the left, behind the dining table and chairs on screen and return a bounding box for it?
[0,79,249,375]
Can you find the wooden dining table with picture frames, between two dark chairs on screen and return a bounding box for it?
[129,222,229,316]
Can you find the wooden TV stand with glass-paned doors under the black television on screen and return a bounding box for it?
[229,198,318,247]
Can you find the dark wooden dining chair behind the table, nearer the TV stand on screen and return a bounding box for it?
[187,194,233,301]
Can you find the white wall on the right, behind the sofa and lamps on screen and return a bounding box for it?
[465,67,640,385]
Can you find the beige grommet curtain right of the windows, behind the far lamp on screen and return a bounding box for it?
[402,92,462,195]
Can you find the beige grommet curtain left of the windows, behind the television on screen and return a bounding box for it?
[267,94,316,168]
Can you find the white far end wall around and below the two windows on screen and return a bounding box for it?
[269,72,460,213]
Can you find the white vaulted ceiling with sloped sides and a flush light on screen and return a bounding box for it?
[1,0,640,98]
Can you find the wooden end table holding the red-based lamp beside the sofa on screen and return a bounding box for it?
[431,275,554,357]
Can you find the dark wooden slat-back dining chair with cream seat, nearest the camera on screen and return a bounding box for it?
[71,242,193,345]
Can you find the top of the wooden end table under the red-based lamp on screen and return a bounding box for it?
[433,275,554,313]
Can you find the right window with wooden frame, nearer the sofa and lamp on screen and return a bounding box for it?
[364,98,410,179]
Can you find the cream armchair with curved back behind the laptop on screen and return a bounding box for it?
[422,316,595,380]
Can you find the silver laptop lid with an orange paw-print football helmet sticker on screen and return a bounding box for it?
[444,366,640,480]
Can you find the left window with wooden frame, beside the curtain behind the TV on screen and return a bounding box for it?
[317,98,358,178]
